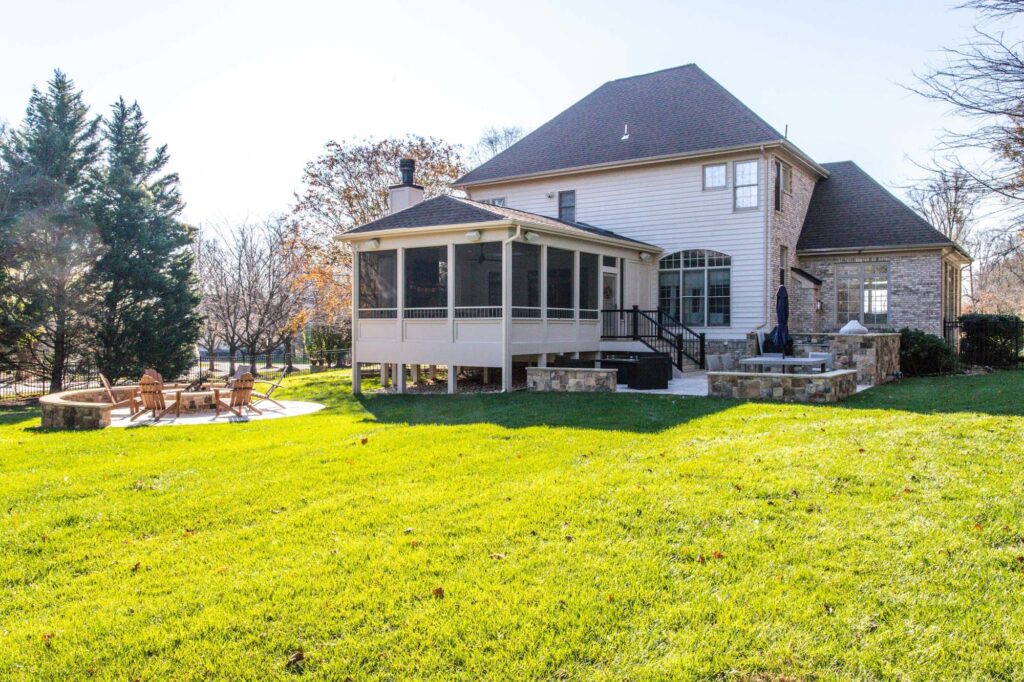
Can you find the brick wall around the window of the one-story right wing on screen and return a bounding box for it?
[791,251,942,336]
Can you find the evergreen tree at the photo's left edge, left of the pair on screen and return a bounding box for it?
[0,71,100,390]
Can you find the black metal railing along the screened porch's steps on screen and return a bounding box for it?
[601,306,706,370]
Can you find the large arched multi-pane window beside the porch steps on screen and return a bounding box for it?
[657,249,732,327]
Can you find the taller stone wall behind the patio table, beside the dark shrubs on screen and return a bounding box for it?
[746,333,899,386]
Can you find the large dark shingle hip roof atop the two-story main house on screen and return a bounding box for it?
[457,65,782,184]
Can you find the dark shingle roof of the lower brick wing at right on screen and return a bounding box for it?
[797,161,955,251]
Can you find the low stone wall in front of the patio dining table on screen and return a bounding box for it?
[708,370,857,402]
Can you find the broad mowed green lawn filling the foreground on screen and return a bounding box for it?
[0,373,1024,680]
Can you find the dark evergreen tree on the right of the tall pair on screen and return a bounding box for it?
[92,99,201,378]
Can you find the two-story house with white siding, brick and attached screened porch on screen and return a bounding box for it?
[346,65,970,389]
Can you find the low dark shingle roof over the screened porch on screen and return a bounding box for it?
[346,196,658,249]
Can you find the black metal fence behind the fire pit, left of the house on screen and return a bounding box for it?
[0,348,352,401]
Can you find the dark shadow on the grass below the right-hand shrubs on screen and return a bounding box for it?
[831,370,1024,417]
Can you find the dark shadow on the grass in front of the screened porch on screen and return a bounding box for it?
[356,391,741,433]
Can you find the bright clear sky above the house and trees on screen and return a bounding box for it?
[0,0,987,222]
